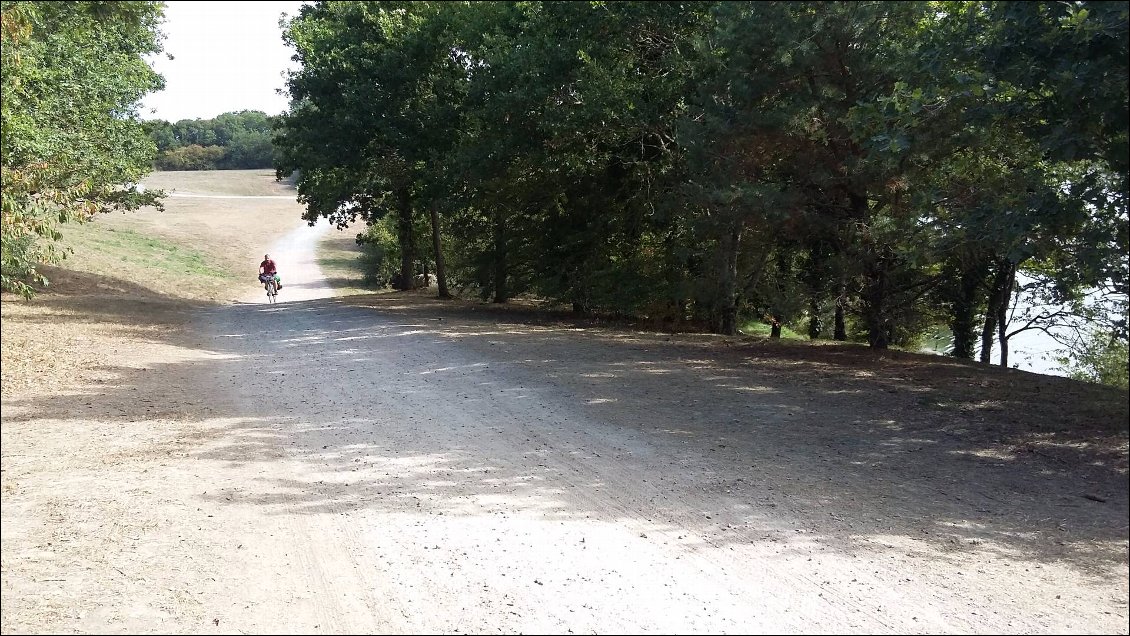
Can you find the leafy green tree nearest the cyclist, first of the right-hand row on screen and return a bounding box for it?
[276,2,464,296]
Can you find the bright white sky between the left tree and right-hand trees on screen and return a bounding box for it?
[139,1,303,122]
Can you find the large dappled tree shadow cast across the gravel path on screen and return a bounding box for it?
[5,294,1128,574]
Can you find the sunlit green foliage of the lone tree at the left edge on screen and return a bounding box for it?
[0,1,163,297]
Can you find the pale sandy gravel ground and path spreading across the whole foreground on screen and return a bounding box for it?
[0,171,1128,634]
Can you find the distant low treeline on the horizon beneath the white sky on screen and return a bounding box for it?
[145,111,275,171]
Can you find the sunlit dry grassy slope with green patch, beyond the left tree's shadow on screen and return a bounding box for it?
[44,171,301,302]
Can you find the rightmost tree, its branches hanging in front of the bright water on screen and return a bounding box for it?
[946,2,1130,364]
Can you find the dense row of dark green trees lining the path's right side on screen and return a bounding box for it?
[276,1,1130,368]
